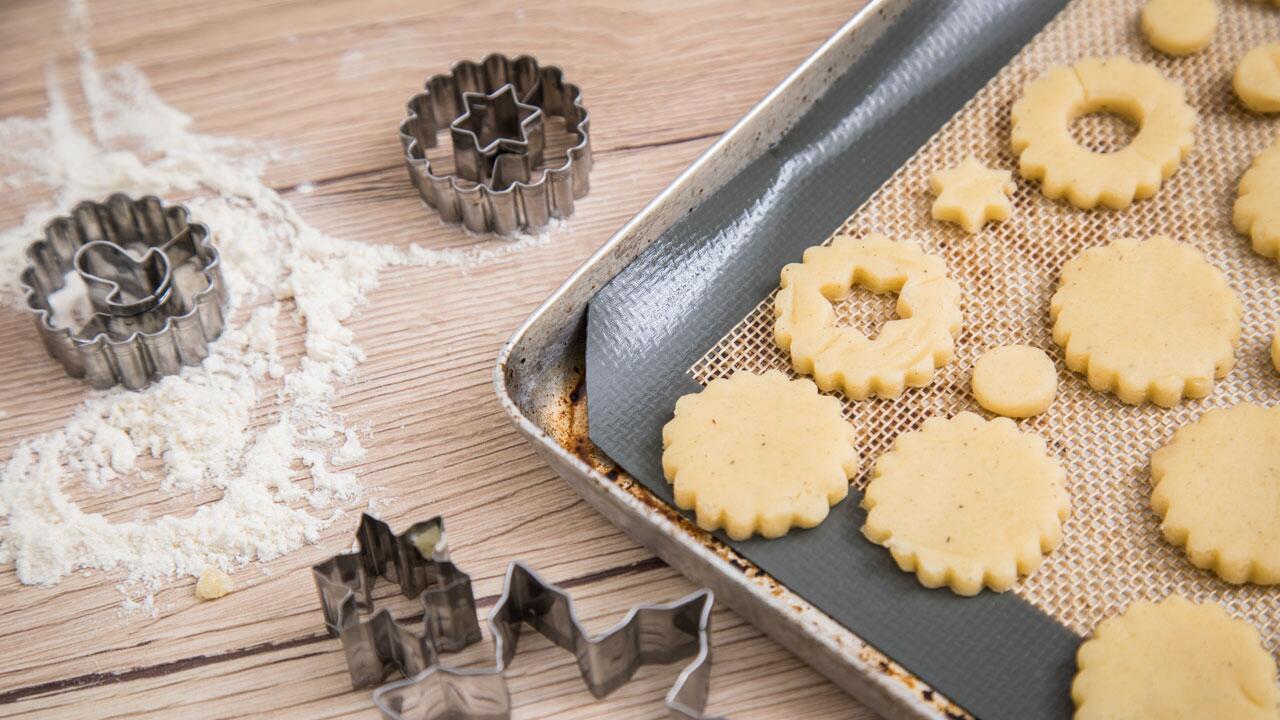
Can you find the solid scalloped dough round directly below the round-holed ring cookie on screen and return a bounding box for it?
[1050,236,1242,407]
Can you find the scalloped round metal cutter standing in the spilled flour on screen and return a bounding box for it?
[20,195,227,389]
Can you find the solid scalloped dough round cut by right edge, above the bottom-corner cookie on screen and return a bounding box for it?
[1151,402,1280,585]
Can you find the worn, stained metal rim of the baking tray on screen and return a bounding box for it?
[494,0,964,719]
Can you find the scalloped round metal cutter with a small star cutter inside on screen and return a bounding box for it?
[399,54,591,234]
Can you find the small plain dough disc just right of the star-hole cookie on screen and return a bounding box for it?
[973,345,1057,418]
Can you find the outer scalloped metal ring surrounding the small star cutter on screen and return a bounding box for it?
[399,54,591,234]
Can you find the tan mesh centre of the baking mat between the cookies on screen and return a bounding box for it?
[692,0,1280,653]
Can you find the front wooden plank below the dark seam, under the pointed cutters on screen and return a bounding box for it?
[0,568,870,720]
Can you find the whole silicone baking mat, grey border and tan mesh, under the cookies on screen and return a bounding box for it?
[588,0,1280,717]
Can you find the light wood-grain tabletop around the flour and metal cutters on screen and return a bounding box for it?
[0,0,869,717]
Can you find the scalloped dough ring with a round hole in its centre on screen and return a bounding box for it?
[1012,58,1196,210]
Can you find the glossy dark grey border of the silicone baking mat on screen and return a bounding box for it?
[586,0,1079,719]
